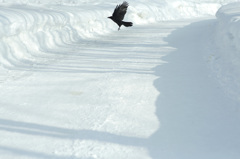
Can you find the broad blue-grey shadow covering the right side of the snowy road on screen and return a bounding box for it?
[148,19,240,159]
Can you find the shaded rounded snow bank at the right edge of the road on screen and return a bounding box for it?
[213,2,240,100]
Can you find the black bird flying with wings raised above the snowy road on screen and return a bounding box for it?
[108,1,132,30]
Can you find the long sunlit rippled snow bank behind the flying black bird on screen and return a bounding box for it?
[0,0,237,67]
